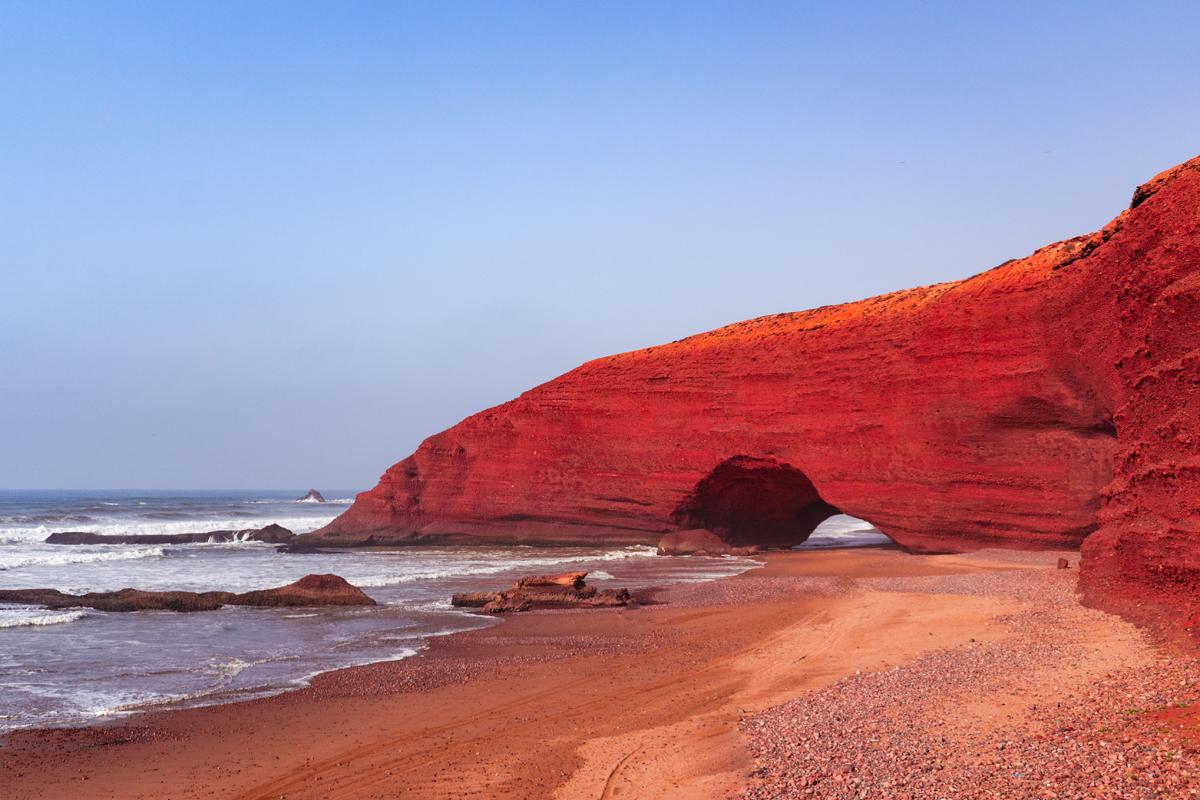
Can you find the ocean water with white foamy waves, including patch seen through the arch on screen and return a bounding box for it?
[0,491,887,730]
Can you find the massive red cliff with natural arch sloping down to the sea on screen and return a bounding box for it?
[314,158,1200,623]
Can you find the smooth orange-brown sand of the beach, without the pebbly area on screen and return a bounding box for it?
[0,547,1192,799]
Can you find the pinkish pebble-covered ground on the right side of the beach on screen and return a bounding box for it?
[740,553,1200,800]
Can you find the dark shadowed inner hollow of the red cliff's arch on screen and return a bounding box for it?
[671,456,841,548]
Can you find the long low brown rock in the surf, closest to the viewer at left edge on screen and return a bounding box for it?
[0,575,376,612]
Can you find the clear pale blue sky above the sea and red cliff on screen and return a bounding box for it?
[0,0,1200,489]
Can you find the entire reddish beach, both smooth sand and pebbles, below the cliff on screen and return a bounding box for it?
[0,548,1200,800]
